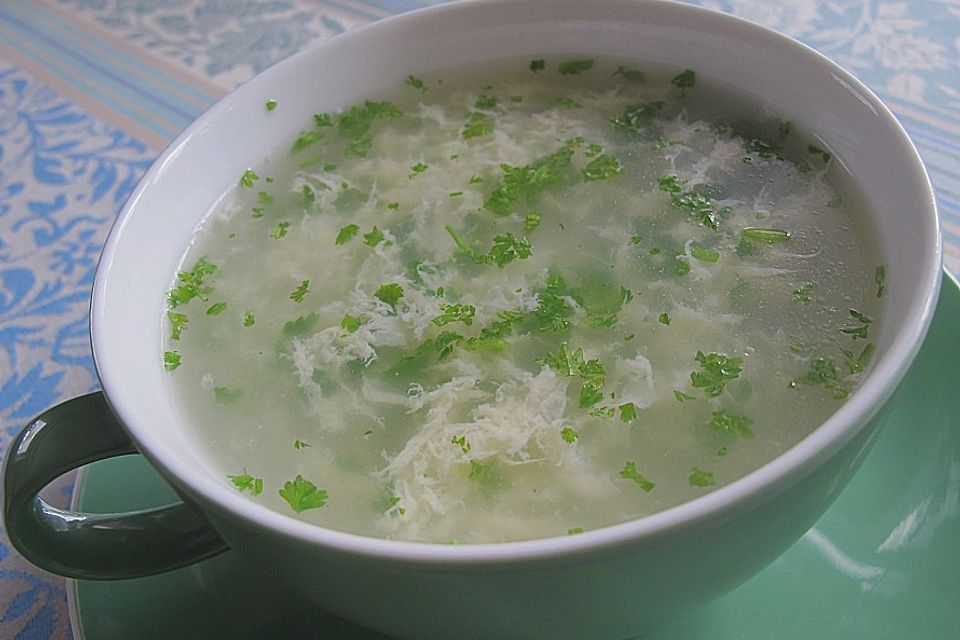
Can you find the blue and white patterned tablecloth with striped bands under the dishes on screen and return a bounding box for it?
[0,0,960,640]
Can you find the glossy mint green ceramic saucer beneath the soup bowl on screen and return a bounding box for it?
[70,277,960,640]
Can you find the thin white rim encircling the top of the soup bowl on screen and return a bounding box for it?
[90,0,942,566]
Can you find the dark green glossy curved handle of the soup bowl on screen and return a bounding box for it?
[3,392,228,580]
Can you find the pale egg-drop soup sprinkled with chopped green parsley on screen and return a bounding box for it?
[162,57,883,543]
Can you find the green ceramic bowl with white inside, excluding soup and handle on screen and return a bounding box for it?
[3,0,940,640]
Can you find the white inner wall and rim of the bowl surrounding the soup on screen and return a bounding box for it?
[92,0,940,555]
